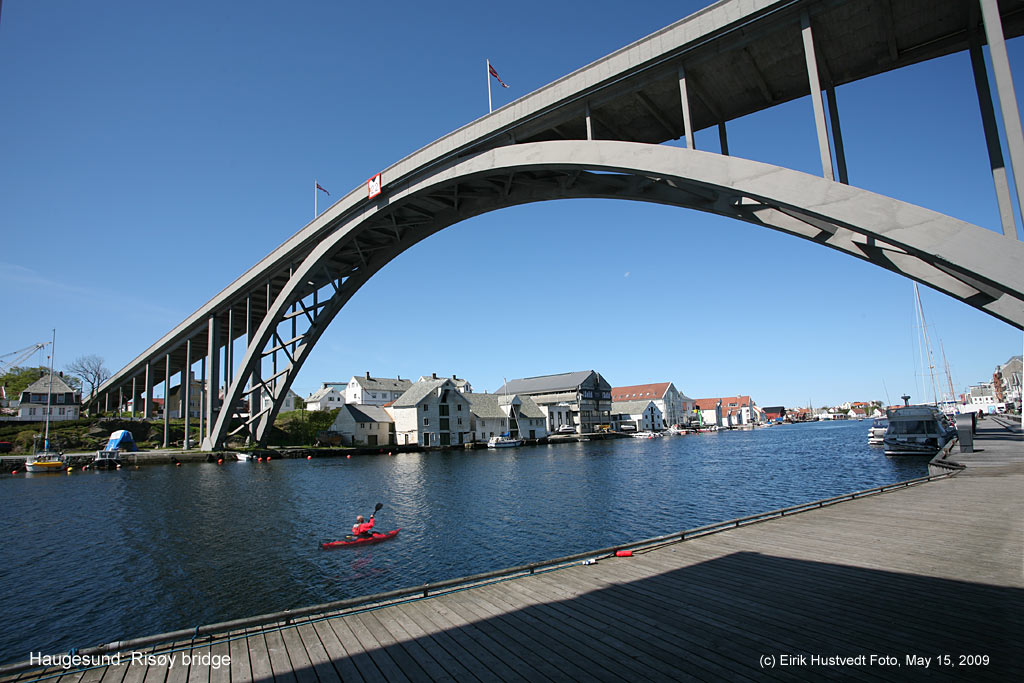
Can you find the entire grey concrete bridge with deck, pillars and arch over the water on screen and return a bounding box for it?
[90,0,1024,450]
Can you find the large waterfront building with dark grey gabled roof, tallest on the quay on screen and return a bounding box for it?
[495,370,611,433]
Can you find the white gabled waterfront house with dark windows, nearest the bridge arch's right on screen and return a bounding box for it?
[390,379,473,446]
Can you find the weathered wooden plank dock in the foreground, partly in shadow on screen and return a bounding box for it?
[0,419,1024,683]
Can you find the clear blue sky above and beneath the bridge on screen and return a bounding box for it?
[0,0,1024,407]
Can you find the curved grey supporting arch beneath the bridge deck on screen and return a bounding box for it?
[203,140,1024,450]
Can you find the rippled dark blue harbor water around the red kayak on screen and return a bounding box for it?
[0,422,928,664]
